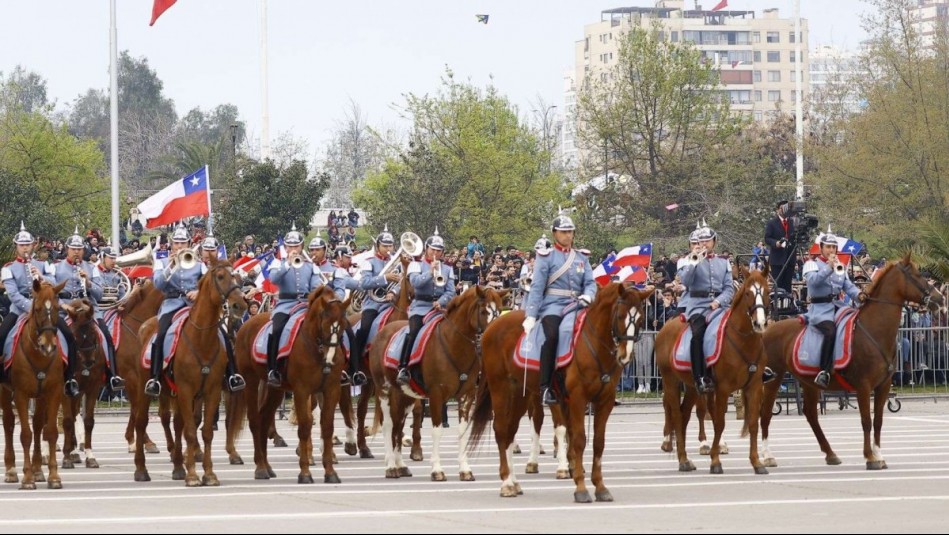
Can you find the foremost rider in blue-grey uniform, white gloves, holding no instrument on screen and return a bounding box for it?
[524,214,596,405]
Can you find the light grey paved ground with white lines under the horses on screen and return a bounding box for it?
[0,400,949,533]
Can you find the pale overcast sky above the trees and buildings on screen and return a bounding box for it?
[0,0,869,154]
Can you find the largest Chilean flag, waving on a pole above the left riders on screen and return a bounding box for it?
[138,166,210,228]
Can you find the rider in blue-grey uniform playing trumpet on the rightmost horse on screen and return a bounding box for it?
[801,228,860,387]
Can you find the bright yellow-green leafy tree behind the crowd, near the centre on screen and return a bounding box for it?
[353,71,562,246]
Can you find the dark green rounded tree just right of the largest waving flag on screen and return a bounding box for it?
[214,160,329,248]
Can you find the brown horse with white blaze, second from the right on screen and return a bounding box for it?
[656,267,770,474]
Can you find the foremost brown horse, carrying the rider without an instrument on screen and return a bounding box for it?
[468,283,653,503]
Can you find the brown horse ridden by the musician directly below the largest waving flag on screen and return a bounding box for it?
[126,261,247,487]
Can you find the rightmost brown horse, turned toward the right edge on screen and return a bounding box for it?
[746,254,945,470]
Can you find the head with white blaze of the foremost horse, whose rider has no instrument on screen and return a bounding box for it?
[587,283,656,366]
